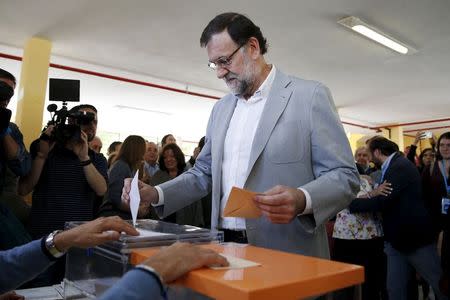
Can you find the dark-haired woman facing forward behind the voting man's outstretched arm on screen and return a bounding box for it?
[150,143,205,227]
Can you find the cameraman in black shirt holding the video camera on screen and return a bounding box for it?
[19,105,107,284]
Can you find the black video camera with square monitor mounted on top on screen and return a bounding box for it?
[44,78,95,145]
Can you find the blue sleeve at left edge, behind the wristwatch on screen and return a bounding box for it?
[0,240,53,294]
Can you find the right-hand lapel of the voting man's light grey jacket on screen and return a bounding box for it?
[246,70,292,182]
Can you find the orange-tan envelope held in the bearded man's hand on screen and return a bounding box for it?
[224,186,261,219]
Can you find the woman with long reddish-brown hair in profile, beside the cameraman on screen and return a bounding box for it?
[99,135,146,219]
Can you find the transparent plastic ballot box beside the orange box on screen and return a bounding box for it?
[64,219,223,299]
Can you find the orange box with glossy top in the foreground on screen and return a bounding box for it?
[131,243,364,300]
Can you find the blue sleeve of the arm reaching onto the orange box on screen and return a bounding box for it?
[100,269,166,300]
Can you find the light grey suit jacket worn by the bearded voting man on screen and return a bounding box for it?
[157,71,359,257]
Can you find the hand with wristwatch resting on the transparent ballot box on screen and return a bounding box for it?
[54,216,139,251]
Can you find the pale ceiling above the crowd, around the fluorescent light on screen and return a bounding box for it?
[0,0,450,134]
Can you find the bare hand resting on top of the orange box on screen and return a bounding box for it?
[143,243,228,283]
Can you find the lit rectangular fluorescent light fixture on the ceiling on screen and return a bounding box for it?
[338,16,416,54]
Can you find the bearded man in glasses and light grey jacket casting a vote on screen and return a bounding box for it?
[122,13,359,257]
